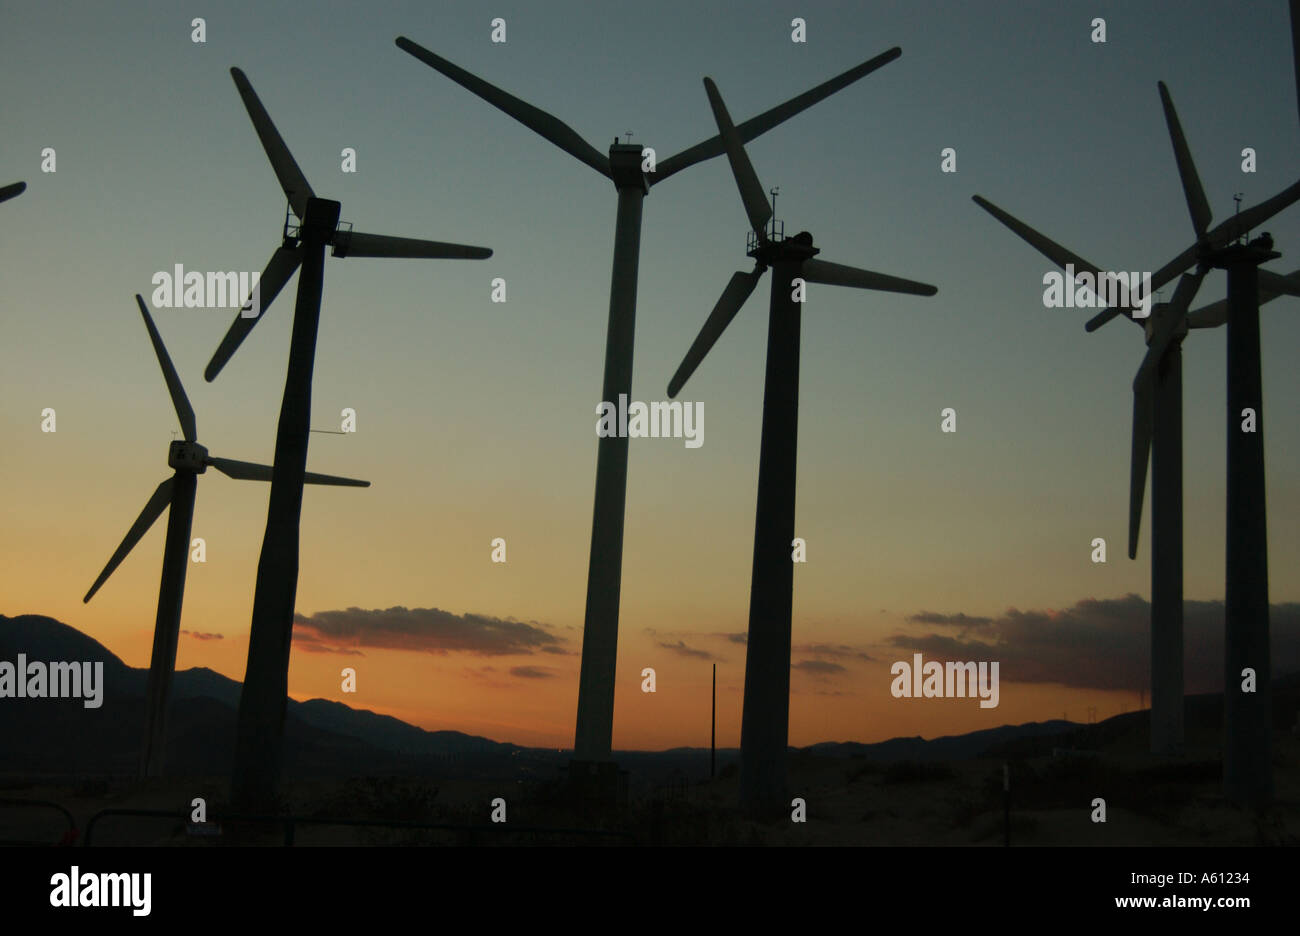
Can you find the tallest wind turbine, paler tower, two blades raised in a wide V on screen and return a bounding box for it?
[397,36,902,774]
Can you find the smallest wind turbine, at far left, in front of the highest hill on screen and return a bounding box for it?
[82,295,371,776]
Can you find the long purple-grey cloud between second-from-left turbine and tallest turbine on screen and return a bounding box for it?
[294,607,564,657]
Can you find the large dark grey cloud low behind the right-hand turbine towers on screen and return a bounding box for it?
[889,594,1300,693]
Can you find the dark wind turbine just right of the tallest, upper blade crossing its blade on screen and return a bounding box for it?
[668,78,937,815]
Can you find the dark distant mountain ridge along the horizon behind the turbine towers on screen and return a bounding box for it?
[0,615,1300,779]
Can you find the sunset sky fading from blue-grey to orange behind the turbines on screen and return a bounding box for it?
[0,0,1300,749]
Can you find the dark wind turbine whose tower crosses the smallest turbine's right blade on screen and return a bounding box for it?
[204,68,491,809]
